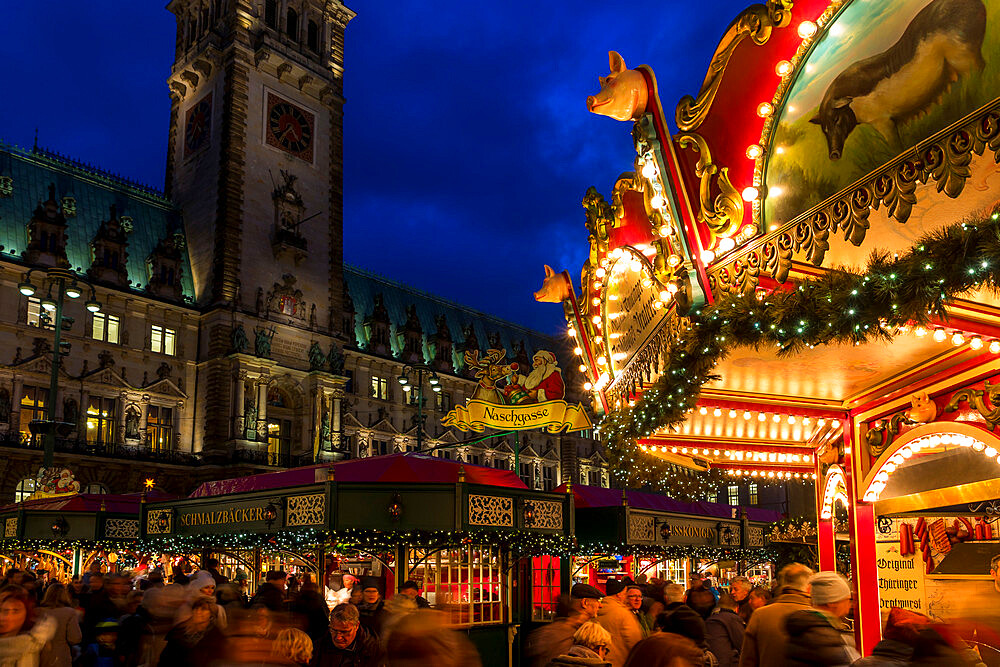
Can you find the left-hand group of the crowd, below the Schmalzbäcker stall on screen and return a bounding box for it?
[0,559,480,667]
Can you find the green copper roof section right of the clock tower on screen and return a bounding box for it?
[344,265,561,369]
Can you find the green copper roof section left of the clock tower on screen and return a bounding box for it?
[0,142,194,297]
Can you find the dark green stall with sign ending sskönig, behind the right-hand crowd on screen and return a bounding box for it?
[556,485,781,589]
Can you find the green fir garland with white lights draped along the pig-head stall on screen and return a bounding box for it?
[601,213,1000,499]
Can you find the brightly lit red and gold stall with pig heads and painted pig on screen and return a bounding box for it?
[538,0,1000,654]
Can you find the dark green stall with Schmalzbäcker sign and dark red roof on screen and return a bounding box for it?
[142,454,573,664]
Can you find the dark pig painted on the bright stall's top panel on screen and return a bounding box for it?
[812,0,986,160]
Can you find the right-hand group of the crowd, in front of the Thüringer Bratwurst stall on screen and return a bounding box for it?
[526,563,984,667]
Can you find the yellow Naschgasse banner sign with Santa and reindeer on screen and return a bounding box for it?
[441,350,592,433]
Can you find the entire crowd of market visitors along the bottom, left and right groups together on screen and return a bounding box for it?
[0,559,982,667]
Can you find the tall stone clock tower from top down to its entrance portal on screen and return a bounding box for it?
[166,0,354,455]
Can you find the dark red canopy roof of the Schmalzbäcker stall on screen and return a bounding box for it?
[190,453,528,498]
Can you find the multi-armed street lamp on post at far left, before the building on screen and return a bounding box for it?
[17,268,101,468]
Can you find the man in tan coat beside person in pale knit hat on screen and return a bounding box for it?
[740,563,812,667]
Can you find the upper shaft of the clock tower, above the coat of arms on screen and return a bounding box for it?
[166,0,354,320]
